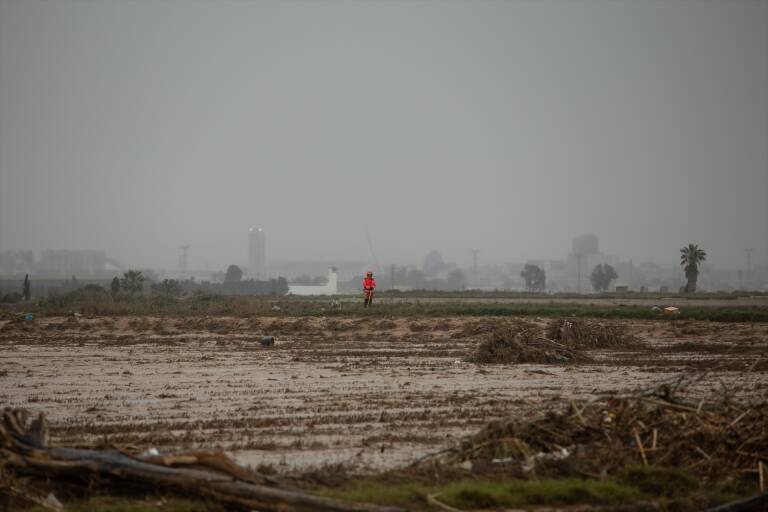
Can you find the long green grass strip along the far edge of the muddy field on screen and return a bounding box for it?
[10,294,768,322]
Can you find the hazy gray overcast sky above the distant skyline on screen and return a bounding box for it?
[0,0,768,269]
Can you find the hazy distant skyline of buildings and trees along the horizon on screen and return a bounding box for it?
[0,228,768,302]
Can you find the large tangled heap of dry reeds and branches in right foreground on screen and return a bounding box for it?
[426,395,768,481]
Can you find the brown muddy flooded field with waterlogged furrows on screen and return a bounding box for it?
[0,317,768,472]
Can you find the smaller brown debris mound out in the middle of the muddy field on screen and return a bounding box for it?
[468,319,634,364]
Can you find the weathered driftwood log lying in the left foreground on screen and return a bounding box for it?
[0,408,401,512]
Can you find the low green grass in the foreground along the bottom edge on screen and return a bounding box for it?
[18,467,744,512]
